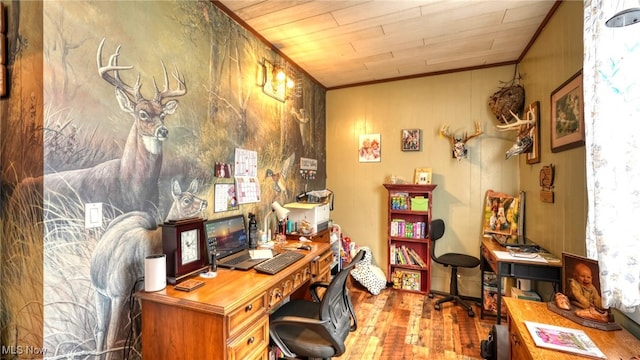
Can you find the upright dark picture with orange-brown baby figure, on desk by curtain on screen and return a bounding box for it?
[562,252,602,309]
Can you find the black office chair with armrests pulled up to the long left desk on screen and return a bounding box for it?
[269,250,364,359]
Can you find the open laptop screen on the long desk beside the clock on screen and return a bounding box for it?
[204,215,249,258]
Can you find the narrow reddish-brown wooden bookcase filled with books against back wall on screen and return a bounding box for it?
[384,184,436,294]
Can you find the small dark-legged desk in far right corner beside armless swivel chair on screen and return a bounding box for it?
[480,237,562,324]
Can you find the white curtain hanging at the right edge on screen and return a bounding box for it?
[583,0,640,316]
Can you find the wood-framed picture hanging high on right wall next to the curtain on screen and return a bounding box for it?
[551,70,584,152]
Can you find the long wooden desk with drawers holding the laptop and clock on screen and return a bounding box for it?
[136,242,333,360]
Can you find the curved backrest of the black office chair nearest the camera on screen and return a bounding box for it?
[320,250,364,342]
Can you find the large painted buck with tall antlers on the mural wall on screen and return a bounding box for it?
[45,39,187,212]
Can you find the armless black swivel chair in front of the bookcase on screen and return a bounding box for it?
[429,219,480,317]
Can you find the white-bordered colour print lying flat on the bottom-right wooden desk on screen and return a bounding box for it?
[524,321,606,359]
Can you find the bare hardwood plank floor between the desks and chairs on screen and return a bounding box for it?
[335,279,495,360]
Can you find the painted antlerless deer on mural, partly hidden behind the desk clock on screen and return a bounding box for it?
[91,179,207,359]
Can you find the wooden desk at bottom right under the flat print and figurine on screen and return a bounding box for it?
[504,298,640,360]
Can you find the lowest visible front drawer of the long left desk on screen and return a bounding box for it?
[227,315,269,360]
